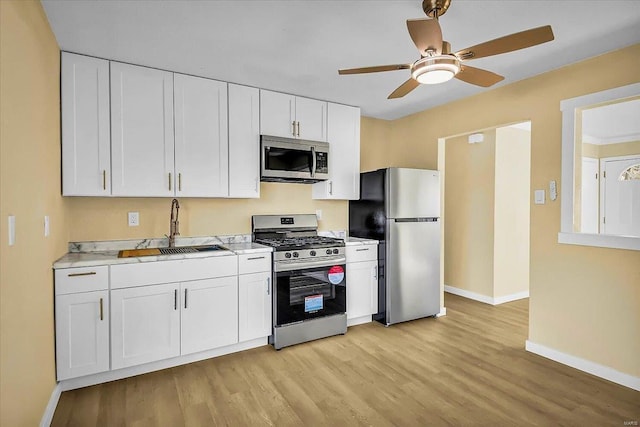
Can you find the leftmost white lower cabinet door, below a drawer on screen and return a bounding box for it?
[55,291,109,381]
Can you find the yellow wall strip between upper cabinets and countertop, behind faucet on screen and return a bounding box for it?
[67,182,349,242]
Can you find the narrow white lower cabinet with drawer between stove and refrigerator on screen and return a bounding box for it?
[346,244,378,324]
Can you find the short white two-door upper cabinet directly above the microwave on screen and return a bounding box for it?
[260,90,327,142]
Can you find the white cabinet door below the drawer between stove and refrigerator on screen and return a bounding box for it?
[347,261,378,319]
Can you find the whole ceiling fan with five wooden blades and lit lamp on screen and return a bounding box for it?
[338,0,553,99]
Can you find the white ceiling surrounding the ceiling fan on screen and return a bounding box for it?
[42,0,640,119]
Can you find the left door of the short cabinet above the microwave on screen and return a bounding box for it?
[260,90,296,138]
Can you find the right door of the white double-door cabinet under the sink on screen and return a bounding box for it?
[180,276,238,354]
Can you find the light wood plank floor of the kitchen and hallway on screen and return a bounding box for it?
[52,294,640,426]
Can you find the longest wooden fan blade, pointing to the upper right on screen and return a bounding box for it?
[456,25,553,61]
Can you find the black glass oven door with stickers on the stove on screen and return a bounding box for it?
[274,263,347,326]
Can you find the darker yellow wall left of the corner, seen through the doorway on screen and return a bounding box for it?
[444,130,496,296]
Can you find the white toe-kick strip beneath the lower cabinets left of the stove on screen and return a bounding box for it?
[58,337,268,391]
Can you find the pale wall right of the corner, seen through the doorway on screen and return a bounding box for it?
[492,127,531,298]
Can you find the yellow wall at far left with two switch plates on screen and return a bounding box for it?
[0,0,68,426]
